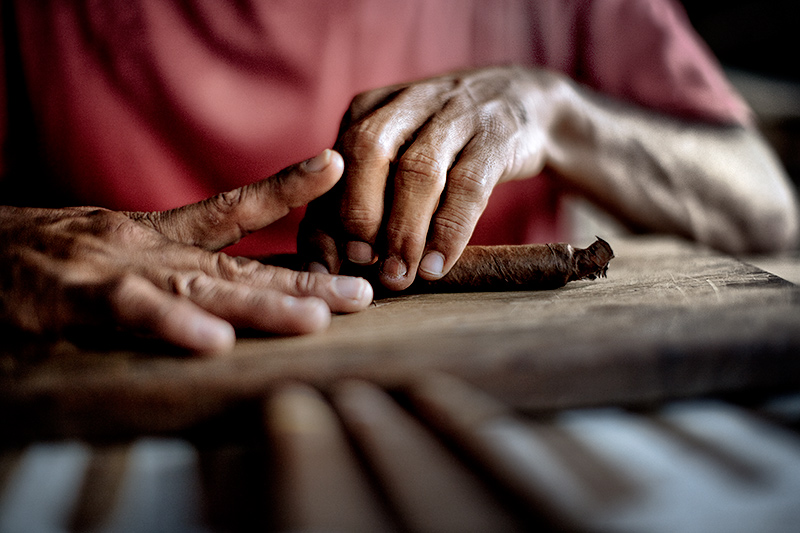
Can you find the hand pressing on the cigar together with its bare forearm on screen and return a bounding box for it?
[298,66,800,290]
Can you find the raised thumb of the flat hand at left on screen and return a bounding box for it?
[129,150,344,250]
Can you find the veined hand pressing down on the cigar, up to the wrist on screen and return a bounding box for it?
[298,67,557,290]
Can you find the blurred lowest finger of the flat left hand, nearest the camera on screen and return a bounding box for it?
[106,276,236,352]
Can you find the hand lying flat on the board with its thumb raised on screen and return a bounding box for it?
[0,150,372,352]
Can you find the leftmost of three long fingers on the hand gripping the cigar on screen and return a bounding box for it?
[337,85,450,264]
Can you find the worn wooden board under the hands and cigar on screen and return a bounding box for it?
[0,238,800,436]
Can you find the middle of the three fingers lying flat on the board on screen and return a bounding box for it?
[162,272,331,335]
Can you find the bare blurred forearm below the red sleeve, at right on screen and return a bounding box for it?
[545,74,798,252]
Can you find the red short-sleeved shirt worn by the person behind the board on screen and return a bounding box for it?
[0,0,748,253]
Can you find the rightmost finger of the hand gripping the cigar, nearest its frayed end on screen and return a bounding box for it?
[419,134,509,281]
